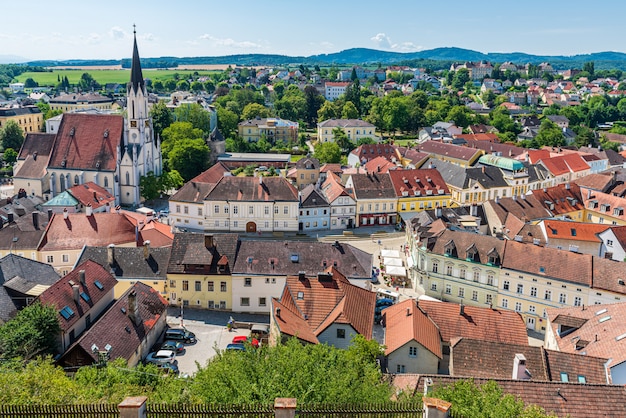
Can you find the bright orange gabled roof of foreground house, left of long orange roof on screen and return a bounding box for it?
[382,299,443,358]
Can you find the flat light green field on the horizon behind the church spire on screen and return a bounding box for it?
[17,69,216,87]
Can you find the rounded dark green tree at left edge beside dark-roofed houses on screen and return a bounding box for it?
[0,302,61,360]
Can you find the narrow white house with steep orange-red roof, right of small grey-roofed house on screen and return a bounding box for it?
[322,172,357,230]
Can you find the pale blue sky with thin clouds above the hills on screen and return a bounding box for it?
[0,0,626,63]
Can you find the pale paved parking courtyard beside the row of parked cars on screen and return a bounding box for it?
[162,308,269,376]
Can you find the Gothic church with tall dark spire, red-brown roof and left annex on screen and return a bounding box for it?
[14,31,163,207]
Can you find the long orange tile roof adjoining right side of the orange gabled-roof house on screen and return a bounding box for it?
[419,300,528,345]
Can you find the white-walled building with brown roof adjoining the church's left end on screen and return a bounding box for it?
[13,133,55,200]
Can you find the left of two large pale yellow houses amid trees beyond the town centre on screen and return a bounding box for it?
[237,117,298,144]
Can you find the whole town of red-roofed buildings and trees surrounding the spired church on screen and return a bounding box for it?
[0,30,626,417]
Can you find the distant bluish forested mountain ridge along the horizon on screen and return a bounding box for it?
[27,47,626,69]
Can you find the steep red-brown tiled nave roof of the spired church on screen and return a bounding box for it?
[49,113,124,171]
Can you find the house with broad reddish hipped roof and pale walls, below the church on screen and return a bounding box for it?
[37,212,137,275]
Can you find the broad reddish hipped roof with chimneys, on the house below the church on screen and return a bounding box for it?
[38,212,136,251]
